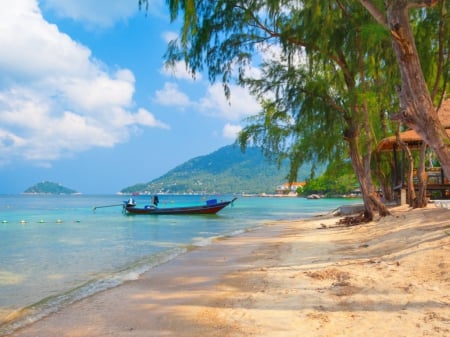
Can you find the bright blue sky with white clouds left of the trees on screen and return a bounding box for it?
[0,0,259,194]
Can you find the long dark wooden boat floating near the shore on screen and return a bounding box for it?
[123,198,237,215]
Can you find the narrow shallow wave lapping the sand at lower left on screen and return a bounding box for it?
[0,247,187,336]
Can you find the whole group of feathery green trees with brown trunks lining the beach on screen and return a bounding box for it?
[139,0,450,220]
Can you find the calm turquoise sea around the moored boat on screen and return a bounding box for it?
[0,195,361,336]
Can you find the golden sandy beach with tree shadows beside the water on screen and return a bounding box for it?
[7,206,450,337]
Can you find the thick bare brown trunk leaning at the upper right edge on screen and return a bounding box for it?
[386,0,450,178]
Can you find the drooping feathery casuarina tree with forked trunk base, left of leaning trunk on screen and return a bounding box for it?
[140,0,448,220]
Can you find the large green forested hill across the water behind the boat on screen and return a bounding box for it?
[121,145,316,194]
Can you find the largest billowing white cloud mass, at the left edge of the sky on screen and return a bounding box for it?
[0,0,168,163]
